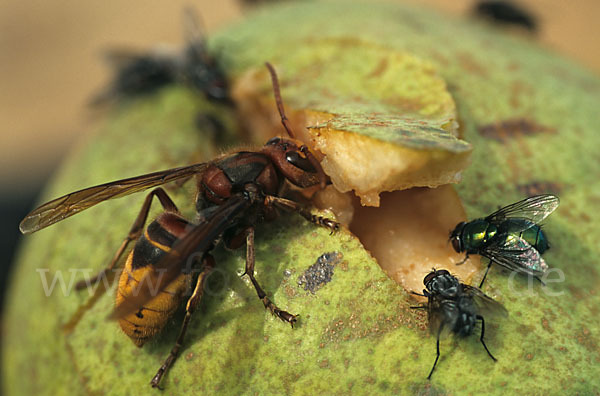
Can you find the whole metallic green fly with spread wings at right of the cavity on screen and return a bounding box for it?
[450,194,560,287]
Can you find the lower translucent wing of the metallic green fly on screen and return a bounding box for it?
[480,234,548,277]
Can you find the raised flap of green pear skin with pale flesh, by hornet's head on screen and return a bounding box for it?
[233,38,472,206]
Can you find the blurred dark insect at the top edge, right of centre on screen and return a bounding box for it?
[473,0,537,33]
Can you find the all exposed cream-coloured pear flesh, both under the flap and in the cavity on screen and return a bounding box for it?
[236,77,481,292]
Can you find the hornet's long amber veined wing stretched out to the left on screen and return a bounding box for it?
[19,163,206,234]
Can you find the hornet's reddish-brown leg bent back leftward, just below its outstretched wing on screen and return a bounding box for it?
[75,187,179,290]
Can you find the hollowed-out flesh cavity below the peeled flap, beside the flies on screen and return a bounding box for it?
[350,186,481,292]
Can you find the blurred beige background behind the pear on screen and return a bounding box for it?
[0,0,600,192]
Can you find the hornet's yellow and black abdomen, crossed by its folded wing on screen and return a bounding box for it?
[116,218,192,347]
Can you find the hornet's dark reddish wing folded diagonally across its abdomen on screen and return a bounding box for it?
[110,195,251,319]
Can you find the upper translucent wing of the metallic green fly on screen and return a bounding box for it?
[485,194,560,227]
